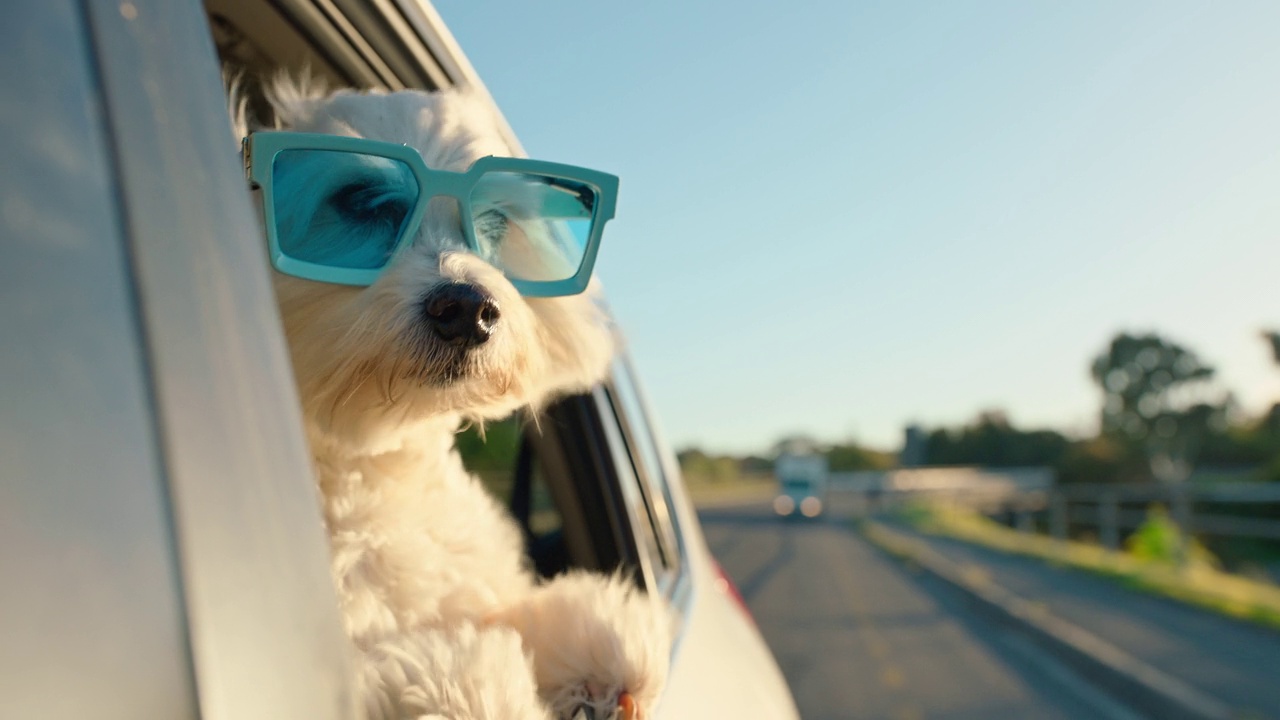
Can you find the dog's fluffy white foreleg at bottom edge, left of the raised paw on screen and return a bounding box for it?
[357,624,552,720]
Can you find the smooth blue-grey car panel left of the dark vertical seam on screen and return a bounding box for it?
[0,0,198,720]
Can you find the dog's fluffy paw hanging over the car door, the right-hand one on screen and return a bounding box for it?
[483,571,672,720]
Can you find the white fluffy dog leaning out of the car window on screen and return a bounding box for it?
[241,81,671,720]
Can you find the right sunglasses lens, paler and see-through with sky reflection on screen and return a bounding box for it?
[471,172,599,282]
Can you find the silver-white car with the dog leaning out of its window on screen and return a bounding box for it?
[0,0,797,720]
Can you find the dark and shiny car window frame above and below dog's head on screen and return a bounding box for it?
[215,0,690,686]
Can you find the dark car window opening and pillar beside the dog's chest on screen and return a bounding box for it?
[457,360,686,597]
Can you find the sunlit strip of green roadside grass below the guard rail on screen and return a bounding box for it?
[897,503,1280,630]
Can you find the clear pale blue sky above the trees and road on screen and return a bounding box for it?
[436,0,1280,451]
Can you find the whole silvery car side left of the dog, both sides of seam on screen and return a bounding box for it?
[0,0,355,720]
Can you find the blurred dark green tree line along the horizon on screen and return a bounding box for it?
[678,331,1280,483]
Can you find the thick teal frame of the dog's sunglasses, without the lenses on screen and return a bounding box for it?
[243,131,618,297]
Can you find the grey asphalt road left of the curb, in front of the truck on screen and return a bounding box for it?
[700,506,1132,720]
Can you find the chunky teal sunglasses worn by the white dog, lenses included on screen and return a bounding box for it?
[244,132,618,297]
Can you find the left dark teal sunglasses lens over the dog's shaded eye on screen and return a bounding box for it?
[271,150,420,270]
